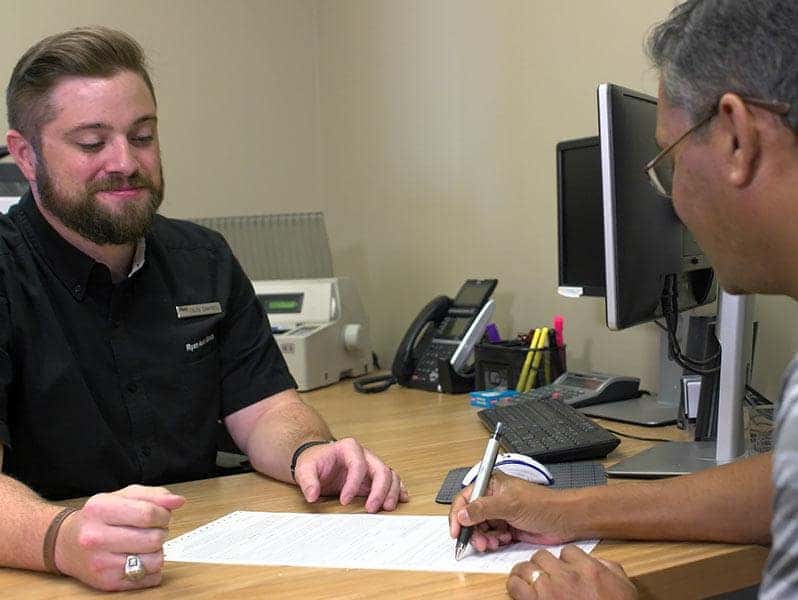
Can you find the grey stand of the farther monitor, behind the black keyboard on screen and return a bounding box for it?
[579,319,689,427]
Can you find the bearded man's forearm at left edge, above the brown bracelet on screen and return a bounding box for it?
[0,475,70,570]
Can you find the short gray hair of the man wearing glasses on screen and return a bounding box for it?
[646,0,798,130]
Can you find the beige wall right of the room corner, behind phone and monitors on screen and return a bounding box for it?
[320,0,798,404]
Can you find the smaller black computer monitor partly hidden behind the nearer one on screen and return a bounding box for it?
[557,136,605,297]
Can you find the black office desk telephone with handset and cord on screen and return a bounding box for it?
[355,279,498,393]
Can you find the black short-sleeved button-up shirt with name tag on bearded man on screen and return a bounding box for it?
[0,193,296,499]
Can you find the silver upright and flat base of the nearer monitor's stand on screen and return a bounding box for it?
[607,290,754,478]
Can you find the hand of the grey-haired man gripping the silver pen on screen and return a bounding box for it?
[449,471,574,552]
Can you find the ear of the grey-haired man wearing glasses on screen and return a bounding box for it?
[718,93,762,187]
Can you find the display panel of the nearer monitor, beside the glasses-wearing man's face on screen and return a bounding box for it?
[598,84,717,329]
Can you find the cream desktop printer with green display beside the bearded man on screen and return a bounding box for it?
[252,277,372,391]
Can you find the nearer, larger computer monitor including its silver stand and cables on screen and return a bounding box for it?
[596,84,751,477]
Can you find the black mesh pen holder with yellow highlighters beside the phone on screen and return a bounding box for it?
[474,340,565,390]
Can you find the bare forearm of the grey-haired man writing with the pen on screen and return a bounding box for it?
[563,454,773,544]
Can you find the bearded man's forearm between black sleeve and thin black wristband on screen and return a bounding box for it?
[228,390,332,482]
